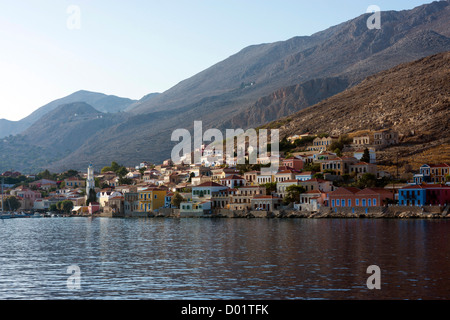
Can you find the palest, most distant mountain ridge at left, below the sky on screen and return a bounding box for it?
[0,90,136,138]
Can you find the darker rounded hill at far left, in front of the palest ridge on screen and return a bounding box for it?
[0,102,124,171]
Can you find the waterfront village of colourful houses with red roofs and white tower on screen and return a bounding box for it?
[0,130,450,218]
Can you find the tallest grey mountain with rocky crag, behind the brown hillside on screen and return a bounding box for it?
[0,1,450,175]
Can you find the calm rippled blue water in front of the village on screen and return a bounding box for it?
[0,218,450,300]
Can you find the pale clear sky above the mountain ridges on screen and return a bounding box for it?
[0,0,432,121]
